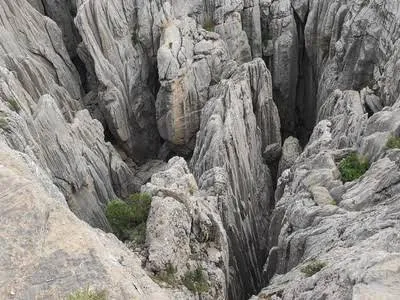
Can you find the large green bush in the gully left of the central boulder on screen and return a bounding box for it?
[106,193,151,242]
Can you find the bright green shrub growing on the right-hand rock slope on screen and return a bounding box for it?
[339,153,369,182]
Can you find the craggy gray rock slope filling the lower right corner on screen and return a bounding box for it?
[255,114,400,299]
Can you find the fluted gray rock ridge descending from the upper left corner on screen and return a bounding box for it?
[0,1,138,229]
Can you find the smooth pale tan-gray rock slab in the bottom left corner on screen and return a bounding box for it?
[0,140,171,300]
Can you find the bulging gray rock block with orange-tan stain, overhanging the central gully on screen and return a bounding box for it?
[156,18,236,151]
